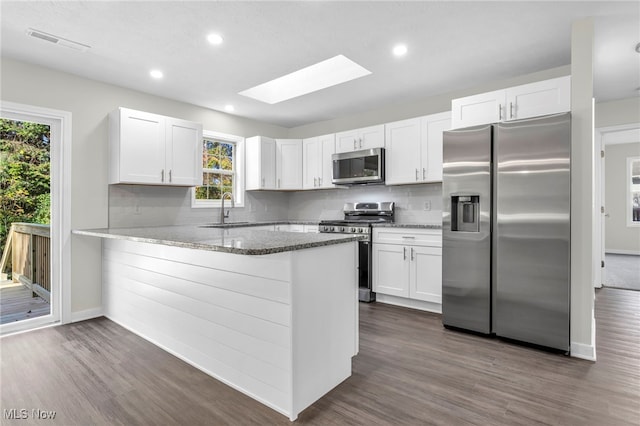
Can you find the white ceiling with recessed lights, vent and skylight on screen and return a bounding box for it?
[0,0,640,127]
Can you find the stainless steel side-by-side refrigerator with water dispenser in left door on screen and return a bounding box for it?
[442,113,571,352]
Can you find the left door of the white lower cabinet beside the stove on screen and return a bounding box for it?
[372,244,409,297]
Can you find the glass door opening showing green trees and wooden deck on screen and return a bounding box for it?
[0,118,51,324]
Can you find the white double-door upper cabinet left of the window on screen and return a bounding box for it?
[109,108,202,186]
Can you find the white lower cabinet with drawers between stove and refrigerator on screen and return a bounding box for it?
[372,228,442,304]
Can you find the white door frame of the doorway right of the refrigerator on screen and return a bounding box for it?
[592,123,640,288]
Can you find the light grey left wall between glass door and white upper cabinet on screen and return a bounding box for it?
[0,57,288,313]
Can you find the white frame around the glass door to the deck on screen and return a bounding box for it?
[0,101,72,336]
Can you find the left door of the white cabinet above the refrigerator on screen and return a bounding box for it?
[451,90,506,129]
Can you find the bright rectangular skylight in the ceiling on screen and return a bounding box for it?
[239,55,371,104]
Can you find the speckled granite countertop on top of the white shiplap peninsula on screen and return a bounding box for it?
[73,222,363,255]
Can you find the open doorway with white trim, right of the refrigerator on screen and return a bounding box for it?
[594,123,640,291]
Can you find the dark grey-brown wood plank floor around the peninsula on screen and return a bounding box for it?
[0,288,640,426]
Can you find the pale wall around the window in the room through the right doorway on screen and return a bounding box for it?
[604,142,640,254]
